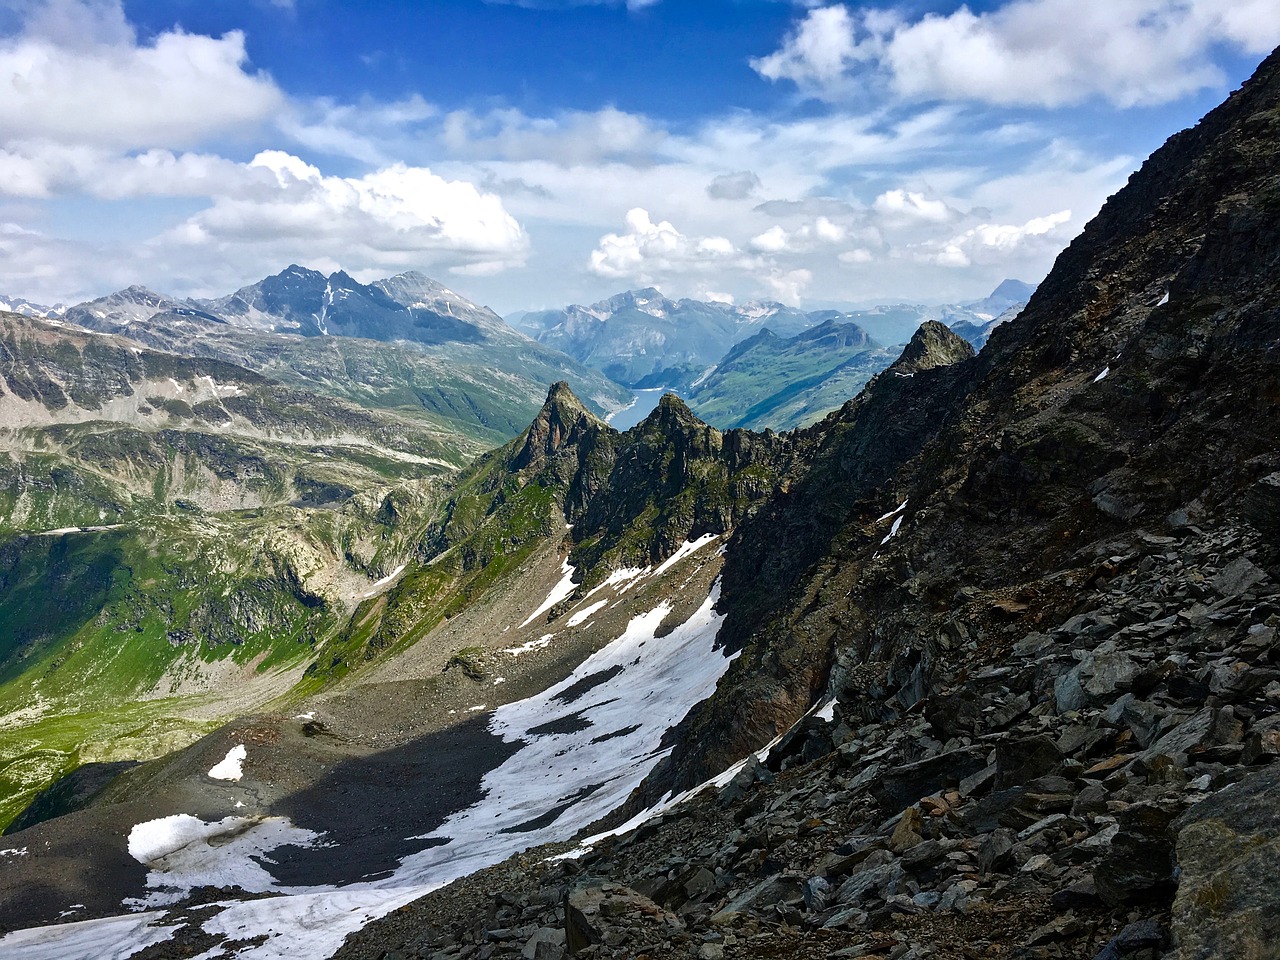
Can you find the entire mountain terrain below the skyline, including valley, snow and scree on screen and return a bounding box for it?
[0,45,1280,960]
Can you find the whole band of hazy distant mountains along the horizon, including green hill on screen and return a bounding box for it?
[0,271,1036,443]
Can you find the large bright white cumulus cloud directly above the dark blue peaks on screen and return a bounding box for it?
[165,150,527,273]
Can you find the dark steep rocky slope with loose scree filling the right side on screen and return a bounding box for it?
[332,47,1280,960]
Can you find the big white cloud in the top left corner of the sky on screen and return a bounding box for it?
[0,0,284,150]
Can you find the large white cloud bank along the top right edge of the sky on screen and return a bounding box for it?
[751,0,1280,108]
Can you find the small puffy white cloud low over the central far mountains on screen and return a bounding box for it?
[589,207,736,283]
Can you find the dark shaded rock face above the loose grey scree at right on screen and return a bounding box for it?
[645,39,1280,803]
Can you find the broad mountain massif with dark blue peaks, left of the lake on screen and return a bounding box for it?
[26,265,628,444]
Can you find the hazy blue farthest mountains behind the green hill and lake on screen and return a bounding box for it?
[509,280,1036,389]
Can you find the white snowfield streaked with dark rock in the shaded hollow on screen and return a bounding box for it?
[0,563,747,960]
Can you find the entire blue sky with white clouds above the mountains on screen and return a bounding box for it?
[0,0,1280,312]
